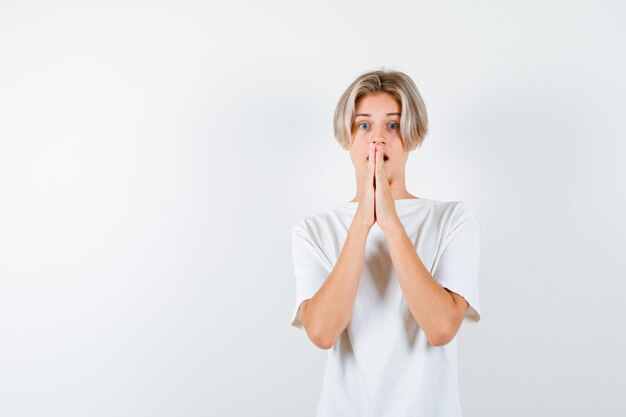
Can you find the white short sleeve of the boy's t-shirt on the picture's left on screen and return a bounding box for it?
[291,224,332,329]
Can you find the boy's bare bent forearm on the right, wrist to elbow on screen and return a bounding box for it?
[385,223,455,345]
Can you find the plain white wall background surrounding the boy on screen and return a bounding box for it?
[0,1,626,417]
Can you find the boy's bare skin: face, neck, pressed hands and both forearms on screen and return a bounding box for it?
[301,93,469,349]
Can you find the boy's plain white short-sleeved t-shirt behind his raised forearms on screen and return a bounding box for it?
[291,198,480,417]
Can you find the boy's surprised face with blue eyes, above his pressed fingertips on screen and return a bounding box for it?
[350,92,409,179]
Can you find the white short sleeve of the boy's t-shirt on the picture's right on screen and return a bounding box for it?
[433,214,480,323]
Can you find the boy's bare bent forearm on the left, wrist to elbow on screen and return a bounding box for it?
[300,223,369,349]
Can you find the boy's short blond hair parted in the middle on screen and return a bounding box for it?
[333,70,428,151]
